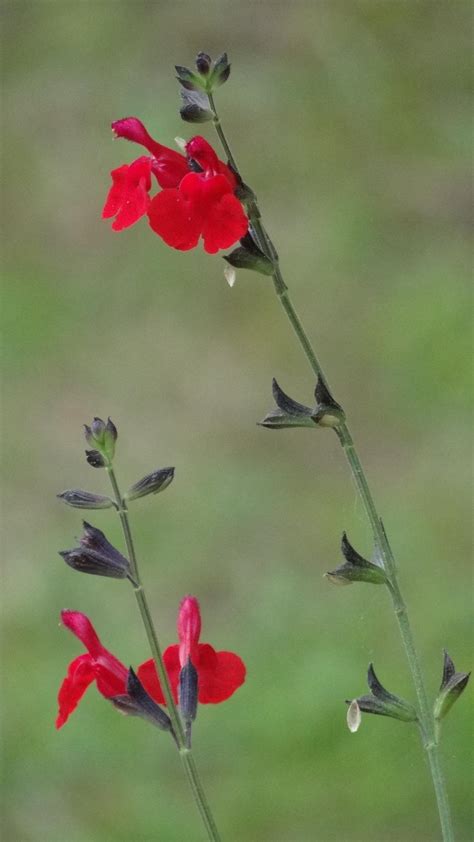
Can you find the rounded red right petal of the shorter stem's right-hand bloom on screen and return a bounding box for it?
[197,643,246,705]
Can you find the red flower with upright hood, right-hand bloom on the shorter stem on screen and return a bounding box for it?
[137,596,245,704]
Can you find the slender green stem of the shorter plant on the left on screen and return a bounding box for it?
[107,465,220,842]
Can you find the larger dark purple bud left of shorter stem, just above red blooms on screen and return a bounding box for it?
[59,521,130,579]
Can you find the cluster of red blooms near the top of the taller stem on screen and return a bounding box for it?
[102,117,248,254]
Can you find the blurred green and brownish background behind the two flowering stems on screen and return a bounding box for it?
[2,0,471,842]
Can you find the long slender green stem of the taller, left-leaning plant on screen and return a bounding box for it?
[209,94,454,842]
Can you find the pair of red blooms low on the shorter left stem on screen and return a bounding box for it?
[56,597,245,728]
